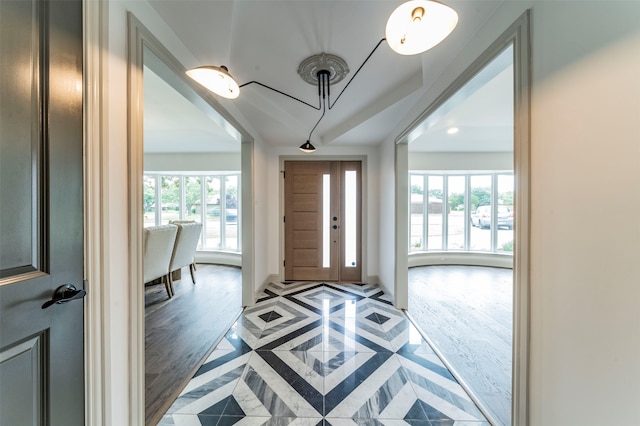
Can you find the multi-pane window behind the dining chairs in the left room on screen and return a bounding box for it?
[143,173,241,252]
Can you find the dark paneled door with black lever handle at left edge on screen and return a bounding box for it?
[0,0,84,426]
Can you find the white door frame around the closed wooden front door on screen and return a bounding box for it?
[278,154,370,283]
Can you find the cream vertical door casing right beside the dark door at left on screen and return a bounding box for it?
[82,0,108,426]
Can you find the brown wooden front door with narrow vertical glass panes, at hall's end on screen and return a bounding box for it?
[284,161,362,282]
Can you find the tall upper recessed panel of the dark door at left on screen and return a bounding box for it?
[0,0,49,285]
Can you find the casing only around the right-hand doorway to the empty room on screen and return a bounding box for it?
[395,10,531,426]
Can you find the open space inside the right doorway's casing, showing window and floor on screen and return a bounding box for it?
[409,45,517,426]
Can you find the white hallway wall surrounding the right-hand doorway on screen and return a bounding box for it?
[380,0,640,426]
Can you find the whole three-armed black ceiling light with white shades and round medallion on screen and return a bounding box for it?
[187,0,458,152]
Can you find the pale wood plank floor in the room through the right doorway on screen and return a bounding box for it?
[408,266,513,426]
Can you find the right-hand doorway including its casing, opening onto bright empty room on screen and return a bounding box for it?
[396,13,530,425]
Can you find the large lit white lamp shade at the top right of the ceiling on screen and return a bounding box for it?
[385,0,458,55]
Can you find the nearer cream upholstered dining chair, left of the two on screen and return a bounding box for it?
[143,225,178,298]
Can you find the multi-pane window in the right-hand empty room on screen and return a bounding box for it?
[409,171,514,254]
